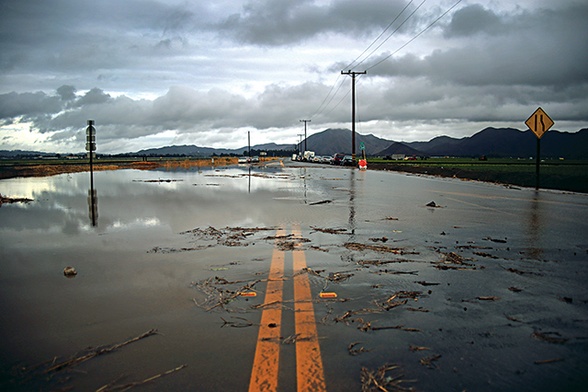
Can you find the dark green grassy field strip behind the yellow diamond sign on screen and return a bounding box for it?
[368,158,588,193]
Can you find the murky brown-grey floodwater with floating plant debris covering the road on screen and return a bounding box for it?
[0,162,588,391]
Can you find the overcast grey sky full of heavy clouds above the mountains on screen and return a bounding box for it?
[0,0,588,153]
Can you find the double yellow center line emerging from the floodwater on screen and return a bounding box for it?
[249,226,327,392]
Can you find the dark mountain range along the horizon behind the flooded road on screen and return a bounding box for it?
[0,128,588,159]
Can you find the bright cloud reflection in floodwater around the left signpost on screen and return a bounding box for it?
[0,165,310,236]
